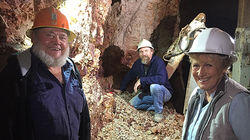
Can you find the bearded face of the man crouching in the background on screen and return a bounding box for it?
[139,47,154,64]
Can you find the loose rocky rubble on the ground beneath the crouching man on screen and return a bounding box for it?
[97,93,184,140]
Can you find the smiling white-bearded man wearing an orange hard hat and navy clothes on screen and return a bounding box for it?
[0,7,90,140]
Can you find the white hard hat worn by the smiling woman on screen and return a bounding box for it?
[188,28,237,62]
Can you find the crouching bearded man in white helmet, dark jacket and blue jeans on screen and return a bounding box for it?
[119,39,173,122]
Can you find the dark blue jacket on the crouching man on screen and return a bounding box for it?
[120,55,173,94]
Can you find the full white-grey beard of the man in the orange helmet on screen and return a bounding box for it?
[32,44,69,67]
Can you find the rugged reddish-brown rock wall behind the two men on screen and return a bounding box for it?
[0,0,183,139]
